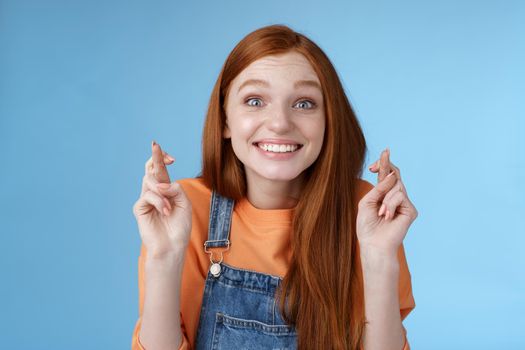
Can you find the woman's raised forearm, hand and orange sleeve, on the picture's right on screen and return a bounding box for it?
[357,149,418,350]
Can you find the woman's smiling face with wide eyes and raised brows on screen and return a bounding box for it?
[224,52,325,186]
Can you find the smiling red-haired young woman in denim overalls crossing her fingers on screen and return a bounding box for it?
[132,25,417,350]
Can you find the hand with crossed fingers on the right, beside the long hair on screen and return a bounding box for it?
[356,148,418,254]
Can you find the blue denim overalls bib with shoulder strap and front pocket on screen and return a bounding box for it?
[195,191,297,350]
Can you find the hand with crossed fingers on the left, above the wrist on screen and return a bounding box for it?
[133,141,191,258]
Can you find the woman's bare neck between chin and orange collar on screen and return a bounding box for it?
[246,174,303,209]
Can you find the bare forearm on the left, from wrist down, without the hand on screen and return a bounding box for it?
[132,247,187,350]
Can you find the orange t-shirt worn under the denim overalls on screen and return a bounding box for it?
[131,178,415,350]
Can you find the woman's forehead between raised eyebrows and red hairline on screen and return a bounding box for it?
[232,52,320,86]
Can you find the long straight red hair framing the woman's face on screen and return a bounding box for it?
[200,25,366,349]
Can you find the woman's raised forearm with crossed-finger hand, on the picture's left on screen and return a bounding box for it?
[132,141,192,350]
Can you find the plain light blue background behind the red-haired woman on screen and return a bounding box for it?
[0,0,525,349]
